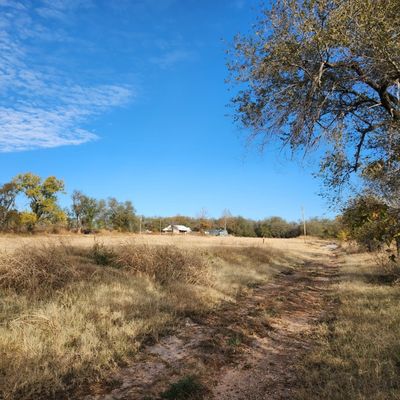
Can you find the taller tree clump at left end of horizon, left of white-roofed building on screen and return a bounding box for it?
[0,173,138,233]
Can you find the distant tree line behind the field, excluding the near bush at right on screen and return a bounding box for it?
[0,173,339,238]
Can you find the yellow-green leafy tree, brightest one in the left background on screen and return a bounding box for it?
[13,173,66,227]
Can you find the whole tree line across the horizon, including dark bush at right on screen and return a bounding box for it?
[0,173,400,252]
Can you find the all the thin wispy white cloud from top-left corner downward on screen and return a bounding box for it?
[0,0,134,152]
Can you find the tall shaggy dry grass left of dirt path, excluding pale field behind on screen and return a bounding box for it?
[0,241,292,400]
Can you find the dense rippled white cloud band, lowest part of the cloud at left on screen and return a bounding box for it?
[0,86,131,152]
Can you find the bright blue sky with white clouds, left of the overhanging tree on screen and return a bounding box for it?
[0,0,331,220]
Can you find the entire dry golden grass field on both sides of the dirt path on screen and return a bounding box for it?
[0,235,400,400]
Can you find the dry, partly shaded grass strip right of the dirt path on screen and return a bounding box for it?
[297,254,400,400]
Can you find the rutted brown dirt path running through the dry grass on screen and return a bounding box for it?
[86,245,338,400]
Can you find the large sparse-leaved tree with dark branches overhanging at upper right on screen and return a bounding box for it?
[229,0,400,200]
